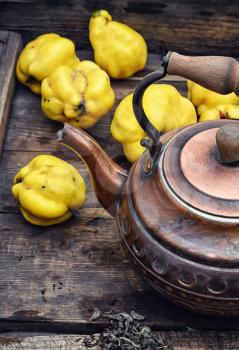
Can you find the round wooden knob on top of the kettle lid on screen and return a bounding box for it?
[216,123,239,164]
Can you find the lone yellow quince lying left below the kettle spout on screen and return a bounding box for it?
[12,155,86,226]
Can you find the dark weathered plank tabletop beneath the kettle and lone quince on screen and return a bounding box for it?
[0,43,239,333]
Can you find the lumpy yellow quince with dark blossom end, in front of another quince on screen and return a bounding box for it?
[41,61,115,129]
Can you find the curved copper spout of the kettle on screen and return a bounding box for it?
[57,124,128,216]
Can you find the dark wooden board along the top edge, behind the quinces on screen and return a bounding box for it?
[0,0,239,56]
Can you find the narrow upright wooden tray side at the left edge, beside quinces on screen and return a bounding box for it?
[0,31,21,153]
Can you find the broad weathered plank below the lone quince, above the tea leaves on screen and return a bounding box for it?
[0,208,190,330]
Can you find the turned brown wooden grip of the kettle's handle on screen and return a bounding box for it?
[167,52,239,96]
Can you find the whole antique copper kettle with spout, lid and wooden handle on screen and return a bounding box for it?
[57,52,239,316]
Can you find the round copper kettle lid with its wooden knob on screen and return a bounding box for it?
[161,120,239,223]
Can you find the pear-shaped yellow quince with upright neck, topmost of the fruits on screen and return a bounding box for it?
[89,10,147,78]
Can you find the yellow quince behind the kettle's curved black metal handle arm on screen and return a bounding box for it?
[110,84,197,163]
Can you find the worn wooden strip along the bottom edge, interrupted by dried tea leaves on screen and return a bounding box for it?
[0,331,239,350]
